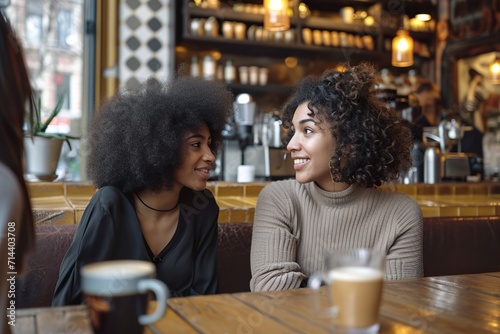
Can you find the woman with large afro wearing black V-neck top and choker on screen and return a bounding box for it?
[52,77,233,306]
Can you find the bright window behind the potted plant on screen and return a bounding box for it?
[4,0,89,181]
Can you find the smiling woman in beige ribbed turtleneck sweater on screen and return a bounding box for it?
[250,64,423,291]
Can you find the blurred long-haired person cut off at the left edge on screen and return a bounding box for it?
[0,11,35,333]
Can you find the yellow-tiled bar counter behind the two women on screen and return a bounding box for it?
[28,182,500,225]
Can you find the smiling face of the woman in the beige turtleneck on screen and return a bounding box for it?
[287,101,335,190]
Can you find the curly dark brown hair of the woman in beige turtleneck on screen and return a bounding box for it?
[282,63,412,188]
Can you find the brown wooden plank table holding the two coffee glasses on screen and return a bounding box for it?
[13,272,500,334]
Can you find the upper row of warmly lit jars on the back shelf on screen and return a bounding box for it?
[182,3,379,60]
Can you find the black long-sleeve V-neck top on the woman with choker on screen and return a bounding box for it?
[52,186,219,306]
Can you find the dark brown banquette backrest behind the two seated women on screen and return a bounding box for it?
[16,217,500,308]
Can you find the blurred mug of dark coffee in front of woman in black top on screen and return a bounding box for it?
[81,260,168,334]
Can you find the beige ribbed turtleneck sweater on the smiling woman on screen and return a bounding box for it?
[250,180,423,291]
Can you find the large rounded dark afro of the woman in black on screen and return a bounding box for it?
[88,77,233,193]
